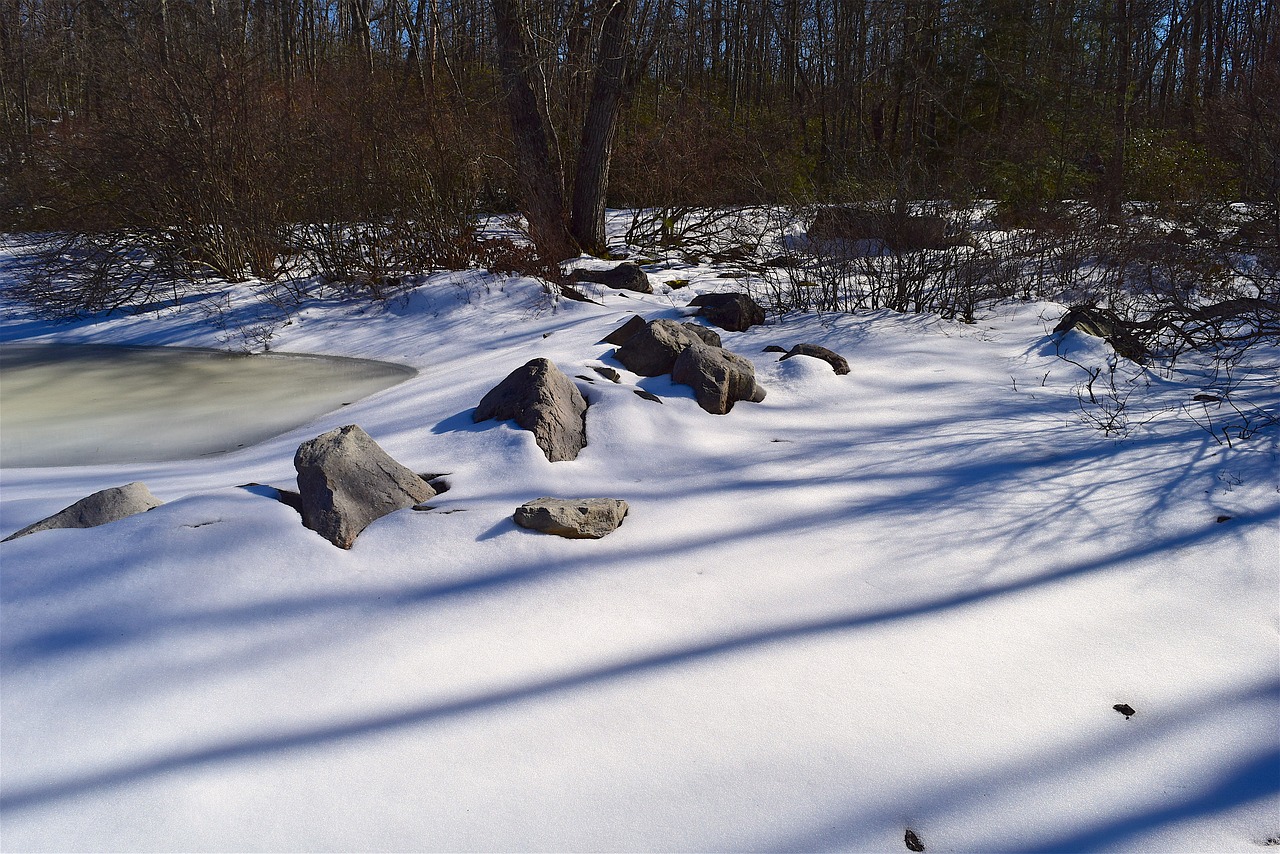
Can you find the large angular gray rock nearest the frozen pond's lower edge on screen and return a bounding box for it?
[293,424,435,548]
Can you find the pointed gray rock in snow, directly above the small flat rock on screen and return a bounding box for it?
[471,359,586,462]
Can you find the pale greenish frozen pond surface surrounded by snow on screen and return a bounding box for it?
[0,344,417,467]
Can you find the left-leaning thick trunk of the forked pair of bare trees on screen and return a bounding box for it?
[493,0,579,261]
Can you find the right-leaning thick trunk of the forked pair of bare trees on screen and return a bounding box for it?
[570,0,635,254]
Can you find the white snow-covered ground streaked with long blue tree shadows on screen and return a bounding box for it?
[0,230,1280,851]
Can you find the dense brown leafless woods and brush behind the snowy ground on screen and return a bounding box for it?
[0,0,1280,303]
